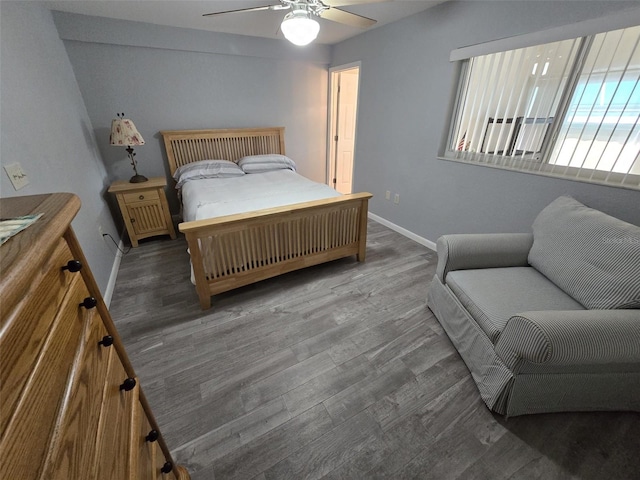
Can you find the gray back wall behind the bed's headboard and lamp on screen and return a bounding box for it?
[54,12,330,213]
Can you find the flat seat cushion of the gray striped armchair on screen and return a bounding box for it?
[447,267,584,344]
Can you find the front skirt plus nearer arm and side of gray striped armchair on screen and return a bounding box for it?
[427,275,640,416]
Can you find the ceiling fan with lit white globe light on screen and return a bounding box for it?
[203,0,385,46]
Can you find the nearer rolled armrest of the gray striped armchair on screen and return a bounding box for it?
[495,310,640,371]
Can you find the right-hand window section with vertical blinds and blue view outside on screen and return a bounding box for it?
[549,26,640,188]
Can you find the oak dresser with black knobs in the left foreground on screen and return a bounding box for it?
[0,193,189,480]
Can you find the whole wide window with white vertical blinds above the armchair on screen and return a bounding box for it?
[445,26,640,189]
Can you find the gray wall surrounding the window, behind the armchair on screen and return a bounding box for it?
[332,1,640,241]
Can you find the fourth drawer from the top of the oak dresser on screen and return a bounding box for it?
[95,348,139,480]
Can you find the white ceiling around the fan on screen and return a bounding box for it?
[45,0,446,45]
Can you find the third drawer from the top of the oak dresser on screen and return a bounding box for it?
[44,310,115,480]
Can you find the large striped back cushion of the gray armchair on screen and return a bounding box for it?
[529,196,640,309]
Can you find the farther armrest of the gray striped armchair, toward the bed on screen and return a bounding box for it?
[436,233,533,283]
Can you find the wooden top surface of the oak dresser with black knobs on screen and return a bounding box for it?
[0,193,80,303]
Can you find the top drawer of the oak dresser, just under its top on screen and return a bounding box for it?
[0,239,80,431]
